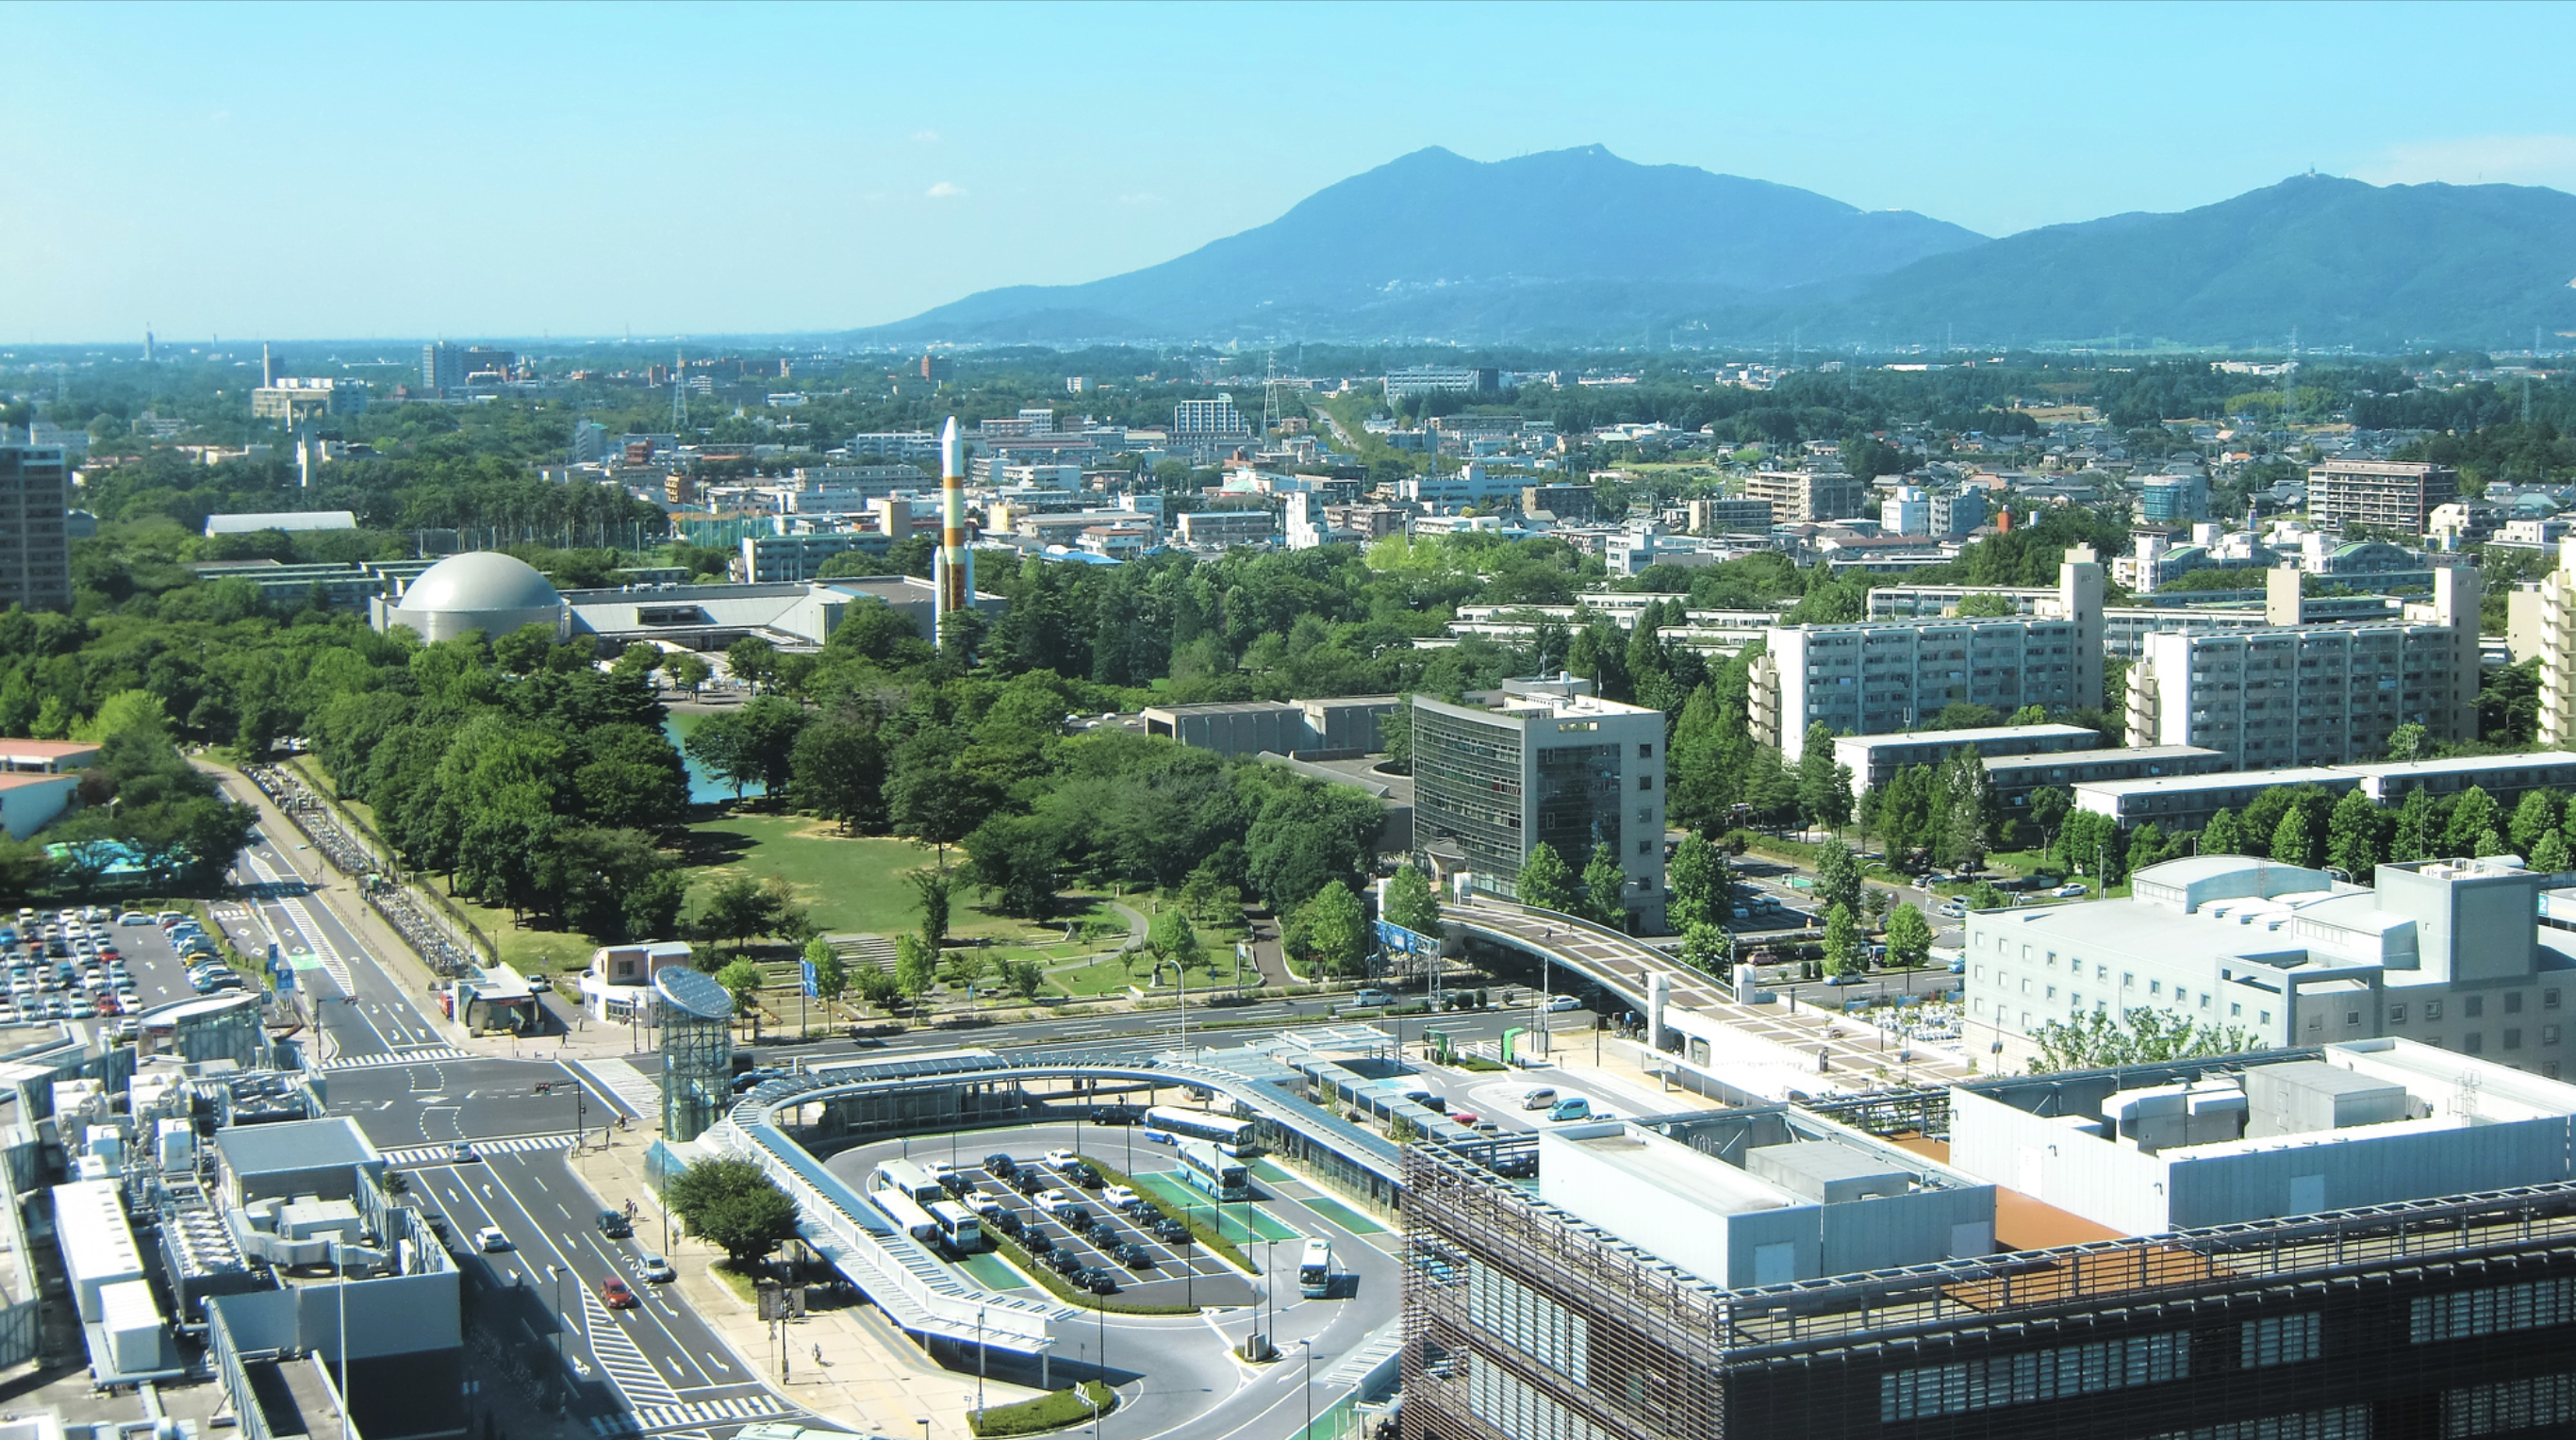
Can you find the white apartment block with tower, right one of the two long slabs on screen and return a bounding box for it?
[2128,567,2483,770]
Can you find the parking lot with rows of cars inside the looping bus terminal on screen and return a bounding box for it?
[827,1126,1267,1306]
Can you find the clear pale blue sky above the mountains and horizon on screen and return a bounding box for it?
[0,3,2576,342]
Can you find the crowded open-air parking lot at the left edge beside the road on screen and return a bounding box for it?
[0,907,237,1025]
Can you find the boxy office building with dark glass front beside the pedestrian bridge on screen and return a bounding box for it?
[1414,677,1664,935]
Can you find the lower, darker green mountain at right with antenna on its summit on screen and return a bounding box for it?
[1772,175,2576,351]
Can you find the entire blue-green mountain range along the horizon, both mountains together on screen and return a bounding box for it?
[852,144,2576,348]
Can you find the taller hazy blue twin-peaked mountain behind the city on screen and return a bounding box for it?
[860,144,1984,342]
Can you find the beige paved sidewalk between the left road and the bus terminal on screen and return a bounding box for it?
[567,1134,1041,1435]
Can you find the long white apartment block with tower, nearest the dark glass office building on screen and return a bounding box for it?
[1749,546,2102,760]
